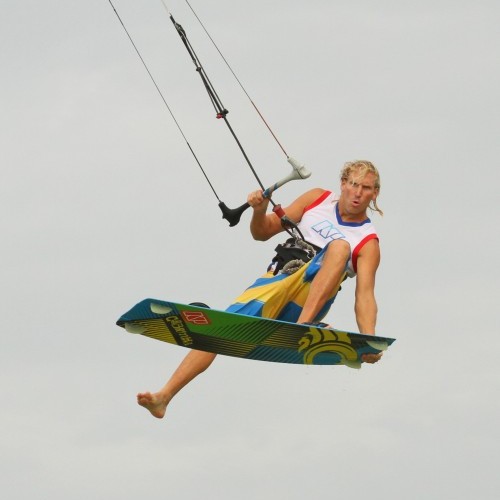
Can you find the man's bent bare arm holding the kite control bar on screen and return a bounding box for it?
[247,188,325,241]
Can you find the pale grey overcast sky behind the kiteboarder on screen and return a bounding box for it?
[0,0,500,500]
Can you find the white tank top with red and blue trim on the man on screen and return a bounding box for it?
[298,191,378,278]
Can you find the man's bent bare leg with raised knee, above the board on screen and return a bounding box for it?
[297,240,351,323]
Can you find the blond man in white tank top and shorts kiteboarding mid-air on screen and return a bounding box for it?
[137,161,382,418]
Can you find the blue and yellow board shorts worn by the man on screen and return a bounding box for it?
[226,247,347,323]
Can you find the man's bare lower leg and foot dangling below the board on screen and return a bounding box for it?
[137,349,216,418]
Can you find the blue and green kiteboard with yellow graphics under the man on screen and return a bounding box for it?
[116,299,394,368]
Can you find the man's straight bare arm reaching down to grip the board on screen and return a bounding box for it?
[354,239,380,335]
